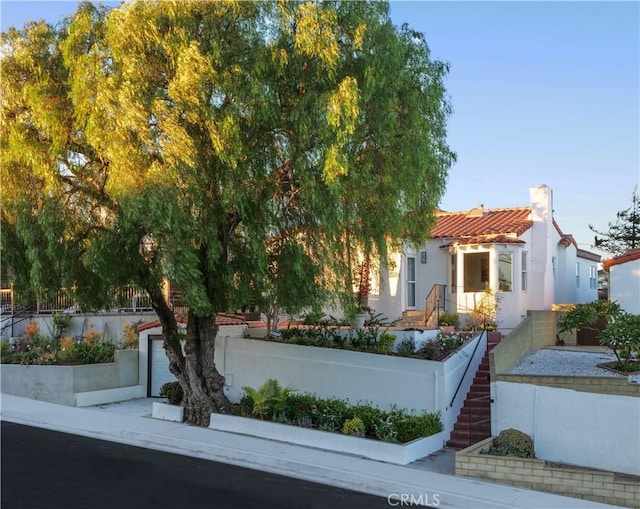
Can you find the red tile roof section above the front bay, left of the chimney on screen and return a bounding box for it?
[431,207,533,239]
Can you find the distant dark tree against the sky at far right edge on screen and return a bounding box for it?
[589,186,640,256]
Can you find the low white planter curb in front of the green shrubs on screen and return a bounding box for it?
[209,414,446,465]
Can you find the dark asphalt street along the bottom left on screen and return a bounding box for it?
[0,421,390,509]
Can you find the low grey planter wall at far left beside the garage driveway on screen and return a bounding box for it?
[0,350,144,406]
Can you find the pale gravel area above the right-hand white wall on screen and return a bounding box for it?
[511,348,640,383]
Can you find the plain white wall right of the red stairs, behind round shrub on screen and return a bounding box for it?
[491,382,640,475]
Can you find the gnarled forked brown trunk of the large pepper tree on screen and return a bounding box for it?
[149,286,231,427]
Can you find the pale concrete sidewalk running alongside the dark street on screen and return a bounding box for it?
[0,394,614,509]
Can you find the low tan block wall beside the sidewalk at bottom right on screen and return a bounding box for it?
[456,437,640,508]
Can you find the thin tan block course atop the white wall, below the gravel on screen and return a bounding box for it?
[492,375,640,397]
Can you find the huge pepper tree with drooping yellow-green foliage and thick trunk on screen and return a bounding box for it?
[0,1,454,425]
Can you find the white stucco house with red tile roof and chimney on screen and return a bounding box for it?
[369,185,600,332]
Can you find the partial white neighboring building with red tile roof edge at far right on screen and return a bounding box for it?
[602,249,640,315]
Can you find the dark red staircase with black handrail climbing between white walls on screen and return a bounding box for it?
[447,332,501,449]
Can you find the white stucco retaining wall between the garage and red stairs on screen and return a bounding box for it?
[138,327,480,439]
